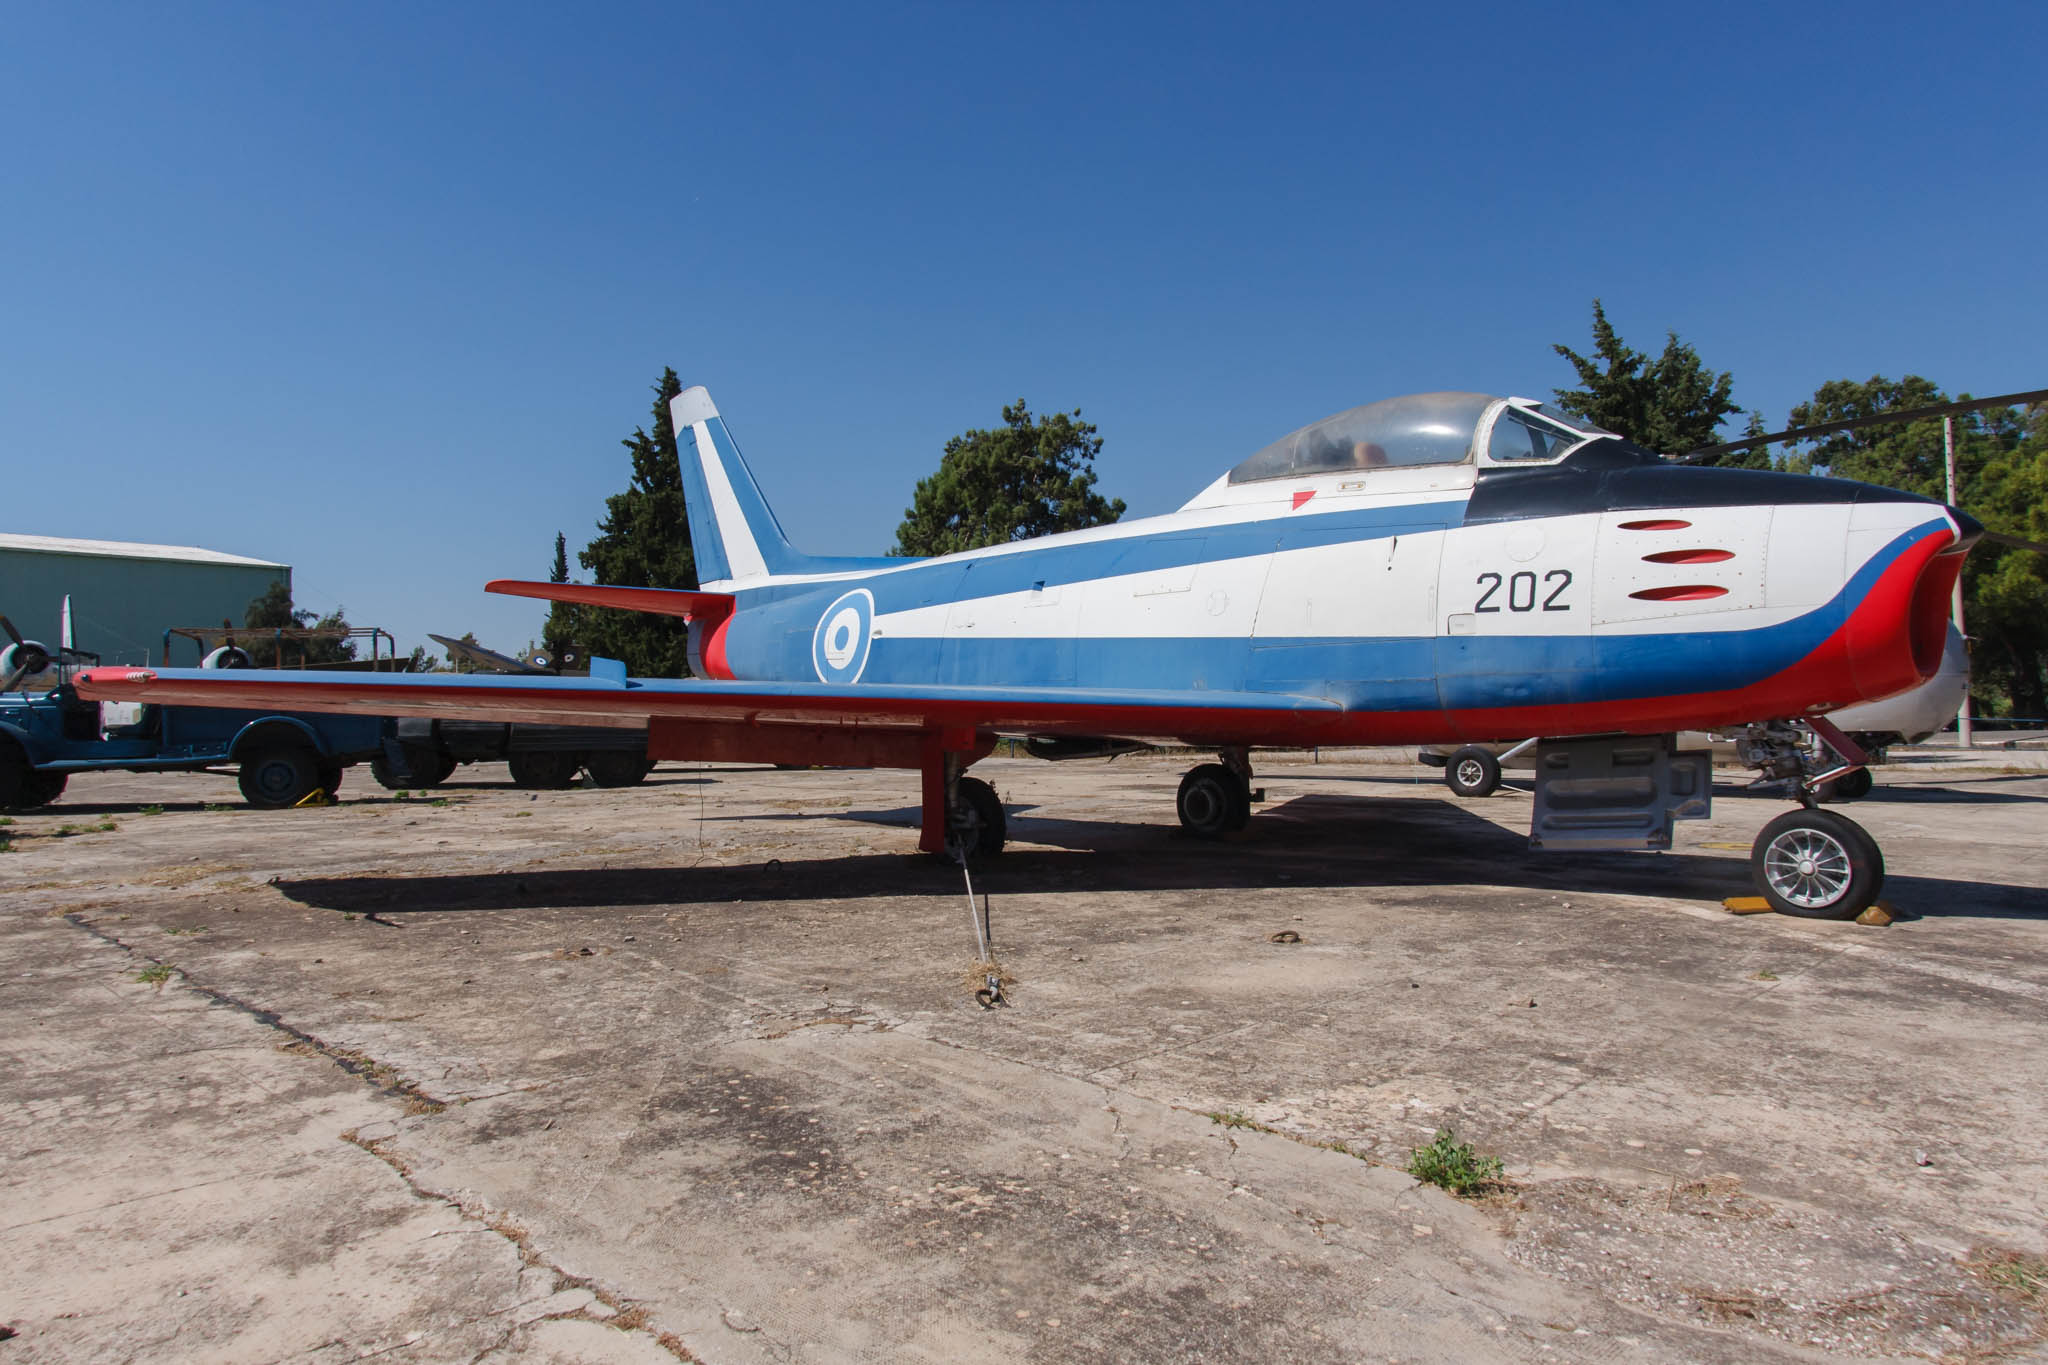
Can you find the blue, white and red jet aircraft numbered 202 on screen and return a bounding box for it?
[78,387,1982,917]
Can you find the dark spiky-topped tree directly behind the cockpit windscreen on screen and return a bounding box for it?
[1552,299,1744,467]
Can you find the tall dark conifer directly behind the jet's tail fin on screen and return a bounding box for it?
[541,368,696,677]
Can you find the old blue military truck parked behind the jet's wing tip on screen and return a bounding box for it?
[0,616,385,810]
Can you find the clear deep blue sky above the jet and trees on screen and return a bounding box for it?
[0,4,2048,663]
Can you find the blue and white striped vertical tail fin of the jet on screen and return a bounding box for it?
[668,385,903,591]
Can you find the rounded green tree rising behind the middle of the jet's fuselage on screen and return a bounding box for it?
[891,399,1124,555]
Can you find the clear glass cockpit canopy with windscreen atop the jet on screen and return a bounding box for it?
[1229,393,1612,483]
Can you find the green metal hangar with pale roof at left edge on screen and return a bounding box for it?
[0,532,291,665]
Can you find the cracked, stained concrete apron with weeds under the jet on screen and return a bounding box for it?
[0,759,2048,1361]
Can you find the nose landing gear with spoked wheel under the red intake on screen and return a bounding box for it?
[1737,716,1884,919]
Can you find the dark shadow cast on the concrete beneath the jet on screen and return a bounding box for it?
[276,794,2048,919]
